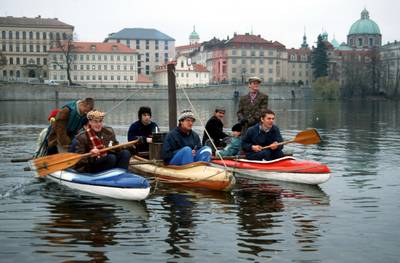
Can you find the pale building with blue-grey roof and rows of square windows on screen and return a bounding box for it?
[104,28,175,77]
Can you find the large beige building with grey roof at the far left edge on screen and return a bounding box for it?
[0,16,74,80]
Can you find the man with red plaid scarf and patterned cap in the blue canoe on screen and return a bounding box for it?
[74,110,131,173]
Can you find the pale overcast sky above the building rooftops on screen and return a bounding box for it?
[0,0,400,48]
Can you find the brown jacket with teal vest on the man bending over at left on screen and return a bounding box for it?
[48,101,85,150]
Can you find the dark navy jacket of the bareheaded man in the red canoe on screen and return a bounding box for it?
[242,123,283,153]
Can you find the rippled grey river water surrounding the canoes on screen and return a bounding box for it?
[0,100,400,262]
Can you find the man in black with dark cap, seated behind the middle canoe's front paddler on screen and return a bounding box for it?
[202,107,229,147]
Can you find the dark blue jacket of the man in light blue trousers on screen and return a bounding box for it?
[162,127,201,163]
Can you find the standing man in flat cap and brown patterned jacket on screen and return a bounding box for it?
[237,77,268,130]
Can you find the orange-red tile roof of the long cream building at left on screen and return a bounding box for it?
[49,42,136,54]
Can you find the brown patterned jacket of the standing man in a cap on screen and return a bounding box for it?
[237,92,268,127]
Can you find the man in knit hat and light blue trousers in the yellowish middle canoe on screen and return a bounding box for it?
[162,110,211,165]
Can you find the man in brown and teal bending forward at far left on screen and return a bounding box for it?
[48,98,94,153]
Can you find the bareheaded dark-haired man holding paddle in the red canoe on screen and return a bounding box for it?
[242,110,283,161]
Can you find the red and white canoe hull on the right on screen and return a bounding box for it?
[213,157,331,185]
